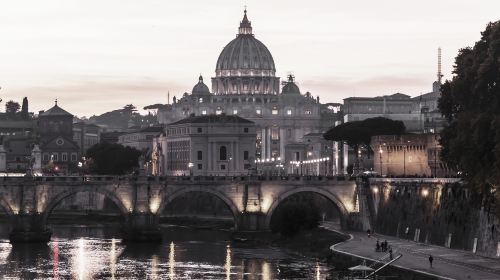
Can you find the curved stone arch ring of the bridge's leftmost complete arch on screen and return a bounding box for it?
[42,186,128,225]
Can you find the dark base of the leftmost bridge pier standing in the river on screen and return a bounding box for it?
[9,213,52,243]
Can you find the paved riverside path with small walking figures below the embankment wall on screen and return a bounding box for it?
[323,224,500,280]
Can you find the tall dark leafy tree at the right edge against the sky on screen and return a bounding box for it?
[438,21,500,203]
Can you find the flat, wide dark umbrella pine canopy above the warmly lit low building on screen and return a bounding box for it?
[323,117,406,148]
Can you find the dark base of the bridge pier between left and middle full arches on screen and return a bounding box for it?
[122,213,162,242]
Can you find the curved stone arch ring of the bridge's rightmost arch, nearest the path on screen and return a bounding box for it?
[266,186,349,228]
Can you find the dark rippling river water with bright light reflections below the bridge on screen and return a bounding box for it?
[0,226,336,280]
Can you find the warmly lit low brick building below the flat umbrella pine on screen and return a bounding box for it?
[370,134,450,177]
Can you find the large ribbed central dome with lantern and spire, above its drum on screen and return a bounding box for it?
[215,10,276,77]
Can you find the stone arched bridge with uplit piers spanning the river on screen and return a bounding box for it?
[0,176,369,242]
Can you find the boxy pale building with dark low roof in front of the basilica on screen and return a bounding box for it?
[162,114,256,176]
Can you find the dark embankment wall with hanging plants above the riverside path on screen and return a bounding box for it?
[365,182,500,257]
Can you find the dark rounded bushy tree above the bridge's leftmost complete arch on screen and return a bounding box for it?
[87,143,141,175]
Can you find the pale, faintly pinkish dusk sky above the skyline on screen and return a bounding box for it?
[0,0,500,116]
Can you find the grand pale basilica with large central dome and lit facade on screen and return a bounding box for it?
[158,10,340,172]
